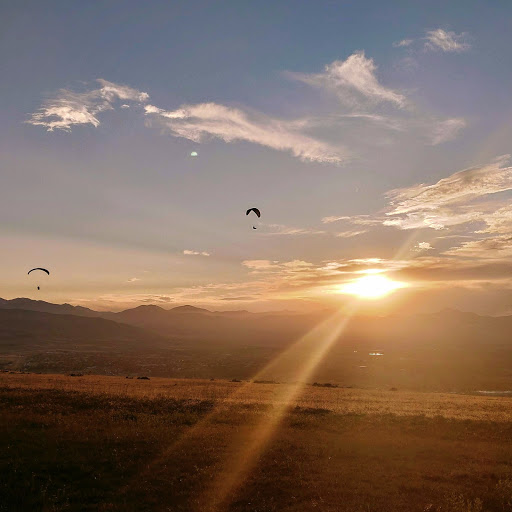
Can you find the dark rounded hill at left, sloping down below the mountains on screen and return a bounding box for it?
[0,309,172,374]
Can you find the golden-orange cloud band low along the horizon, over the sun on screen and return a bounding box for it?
[82,253,512,309]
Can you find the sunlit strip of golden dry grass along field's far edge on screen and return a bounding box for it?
[0,373,512,422]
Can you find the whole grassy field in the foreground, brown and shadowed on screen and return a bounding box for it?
[0,373,512,512]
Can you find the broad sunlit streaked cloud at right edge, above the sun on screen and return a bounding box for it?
[376,155,512,261]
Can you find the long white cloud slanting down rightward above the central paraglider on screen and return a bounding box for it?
[145,103,348,163]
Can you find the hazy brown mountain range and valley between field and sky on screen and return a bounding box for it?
[0,298,512,390]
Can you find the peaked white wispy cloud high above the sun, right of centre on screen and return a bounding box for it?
[289,51,406,107]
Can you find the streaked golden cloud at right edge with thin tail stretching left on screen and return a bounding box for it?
[322,155,512,251]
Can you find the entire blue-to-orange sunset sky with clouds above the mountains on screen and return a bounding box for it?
[0,0,512,315]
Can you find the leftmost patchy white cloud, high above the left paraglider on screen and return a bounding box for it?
[27,78,149,132]
